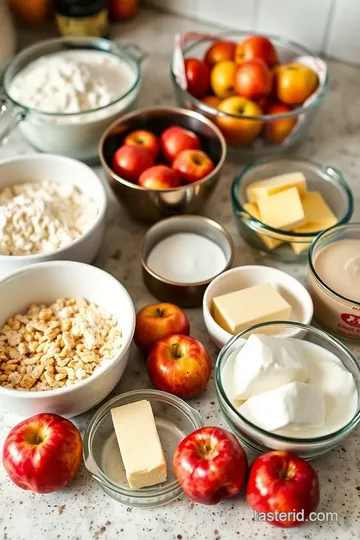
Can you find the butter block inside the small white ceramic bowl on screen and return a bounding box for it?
[212,283,291,334]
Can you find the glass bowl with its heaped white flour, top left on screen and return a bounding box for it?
[0,38,141,162]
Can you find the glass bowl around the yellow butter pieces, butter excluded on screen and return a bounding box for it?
[231,158,354,262]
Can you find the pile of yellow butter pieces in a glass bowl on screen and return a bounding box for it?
[244,172,338,254]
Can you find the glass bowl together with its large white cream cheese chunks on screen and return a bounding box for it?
[215,321,360,459]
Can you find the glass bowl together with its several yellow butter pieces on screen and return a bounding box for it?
[231,159,353,262]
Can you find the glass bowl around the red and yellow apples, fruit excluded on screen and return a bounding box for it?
[171,32,329,163]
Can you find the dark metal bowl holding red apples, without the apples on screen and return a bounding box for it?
[99,107,226,222]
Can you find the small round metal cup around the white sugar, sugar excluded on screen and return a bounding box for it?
[140,216,234,308]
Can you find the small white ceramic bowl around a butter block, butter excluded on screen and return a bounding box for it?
[203,266,313,349]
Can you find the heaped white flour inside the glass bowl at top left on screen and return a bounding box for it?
[9,51,135,114]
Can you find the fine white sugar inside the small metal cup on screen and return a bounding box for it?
[146,233,226,283]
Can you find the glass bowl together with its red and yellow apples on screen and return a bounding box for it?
[171,32,328,162]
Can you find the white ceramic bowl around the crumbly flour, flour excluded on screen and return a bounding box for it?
[0,154,106,277]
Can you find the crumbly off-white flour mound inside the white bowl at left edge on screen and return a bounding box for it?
[0,181,99,255]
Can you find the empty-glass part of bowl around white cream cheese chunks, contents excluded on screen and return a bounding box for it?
[215,321,360,459]
